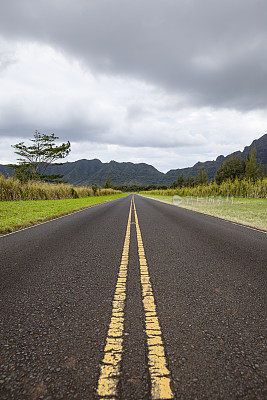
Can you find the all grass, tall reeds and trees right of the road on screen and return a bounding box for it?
[139,148,267,230]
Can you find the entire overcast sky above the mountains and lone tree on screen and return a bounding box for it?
[0,0,267,171]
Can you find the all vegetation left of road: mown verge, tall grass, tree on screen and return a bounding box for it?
[0,131,125,234]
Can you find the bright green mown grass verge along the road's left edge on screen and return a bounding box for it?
[0,194,125,234]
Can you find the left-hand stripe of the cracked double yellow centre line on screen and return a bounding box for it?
[97,200,133,400]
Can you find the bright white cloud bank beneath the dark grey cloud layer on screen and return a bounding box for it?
[0,43,205,147]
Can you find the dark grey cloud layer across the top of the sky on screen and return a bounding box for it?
[0,0,267,110]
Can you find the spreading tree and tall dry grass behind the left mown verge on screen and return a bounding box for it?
[0,131,121,201]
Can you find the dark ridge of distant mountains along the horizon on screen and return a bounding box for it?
[0,134,267,185]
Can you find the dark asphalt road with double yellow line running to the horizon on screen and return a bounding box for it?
[0,196,267,400]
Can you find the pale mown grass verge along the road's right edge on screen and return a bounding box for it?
[142,194,267,231]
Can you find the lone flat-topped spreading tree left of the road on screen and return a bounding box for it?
[10,131,70,182]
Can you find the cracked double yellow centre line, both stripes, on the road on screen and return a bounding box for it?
[97,197,174,400]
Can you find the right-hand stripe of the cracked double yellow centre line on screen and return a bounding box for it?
[133,200,174,400]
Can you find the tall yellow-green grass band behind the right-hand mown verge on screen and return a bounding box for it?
[142,179,267,199]
